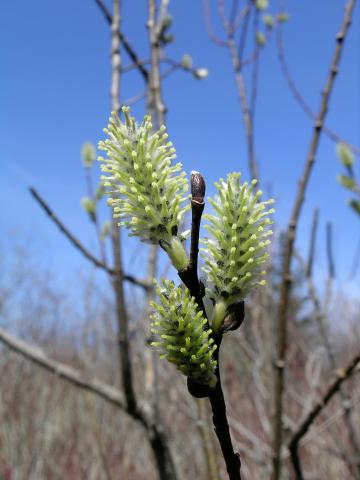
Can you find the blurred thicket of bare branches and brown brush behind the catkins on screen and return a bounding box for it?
[0,0,360,480]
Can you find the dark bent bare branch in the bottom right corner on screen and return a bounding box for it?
[288,353,360,480]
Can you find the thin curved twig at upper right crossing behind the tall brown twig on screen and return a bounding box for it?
[276,26,360,155]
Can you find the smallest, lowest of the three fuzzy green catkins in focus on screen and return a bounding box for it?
[151,279,217,387]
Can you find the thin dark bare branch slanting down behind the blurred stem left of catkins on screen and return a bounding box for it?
[29,187,150,290]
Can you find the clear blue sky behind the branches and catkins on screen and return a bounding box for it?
[0,0,360,291]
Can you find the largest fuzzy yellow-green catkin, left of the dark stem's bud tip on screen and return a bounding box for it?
[99,107,190,270]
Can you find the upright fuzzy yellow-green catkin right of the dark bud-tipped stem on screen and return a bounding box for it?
[201,173,274,331]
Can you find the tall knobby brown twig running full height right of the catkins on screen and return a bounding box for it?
[272,0,355,480]
